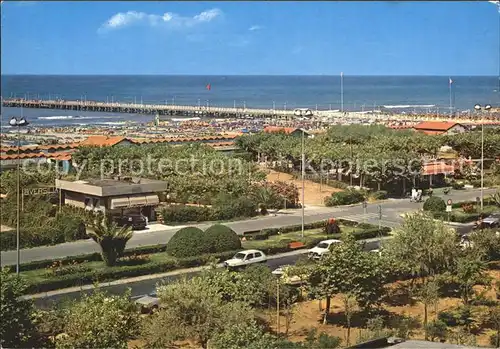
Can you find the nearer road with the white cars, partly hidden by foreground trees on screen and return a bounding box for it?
[33,239,380,308]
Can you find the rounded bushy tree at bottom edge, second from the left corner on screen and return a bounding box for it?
[56,290,140,349]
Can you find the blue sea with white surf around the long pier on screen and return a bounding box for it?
[1,75,500,128]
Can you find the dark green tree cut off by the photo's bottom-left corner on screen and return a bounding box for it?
[0,268,35,348]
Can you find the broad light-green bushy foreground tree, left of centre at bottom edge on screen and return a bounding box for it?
[143,277,253,348]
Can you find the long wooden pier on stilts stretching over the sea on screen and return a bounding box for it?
[2,98,294,119]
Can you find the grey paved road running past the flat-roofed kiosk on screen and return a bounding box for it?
[1,189,495,266]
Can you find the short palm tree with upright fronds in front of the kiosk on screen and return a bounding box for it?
[88,215,133,267]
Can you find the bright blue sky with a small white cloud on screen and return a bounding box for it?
[1,1,500,76]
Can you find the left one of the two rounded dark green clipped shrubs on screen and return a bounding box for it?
[166,227,211,258]
